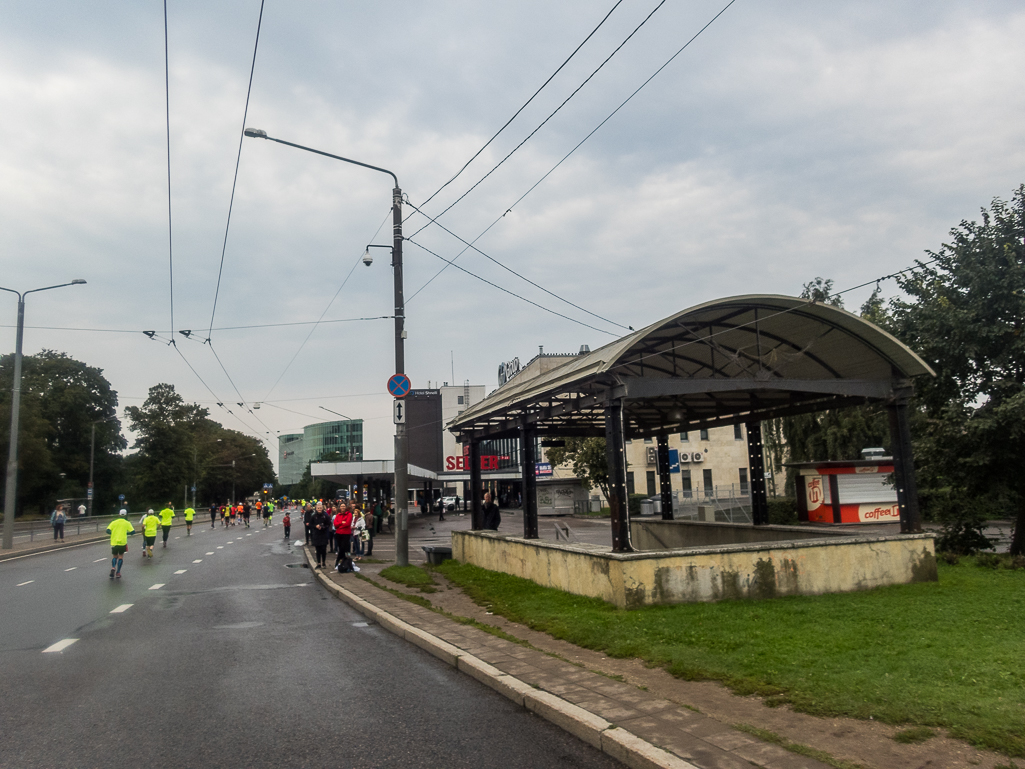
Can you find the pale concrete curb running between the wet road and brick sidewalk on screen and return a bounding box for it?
[302,547,699,769]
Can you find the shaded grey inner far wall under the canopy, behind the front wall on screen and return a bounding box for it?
[630,518,856,551]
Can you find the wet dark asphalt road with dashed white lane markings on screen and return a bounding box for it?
[0,522,620,769]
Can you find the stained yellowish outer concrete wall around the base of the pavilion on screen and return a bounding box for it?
[452,531,937,609]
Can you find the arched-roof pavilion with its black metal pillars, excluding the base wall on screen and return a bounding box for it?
[448,294,935,553]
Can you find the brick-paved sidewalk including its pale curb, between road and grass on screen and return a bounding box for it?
[306,551,828,769]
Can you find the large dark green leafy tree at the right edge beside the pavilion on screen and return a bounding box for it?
[891,186,1025,555]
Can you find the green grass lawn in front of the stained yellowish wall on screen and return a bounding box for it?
[439,559,1025,757]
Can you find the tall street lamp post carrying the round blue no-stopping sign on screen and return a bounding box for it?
[244,128,409,566]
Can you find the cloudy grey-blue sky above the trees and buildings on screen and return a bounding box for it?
[0,0,1025,460]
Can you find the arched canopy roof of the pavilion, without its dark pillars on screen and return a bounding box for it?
[449,294,935,440]
